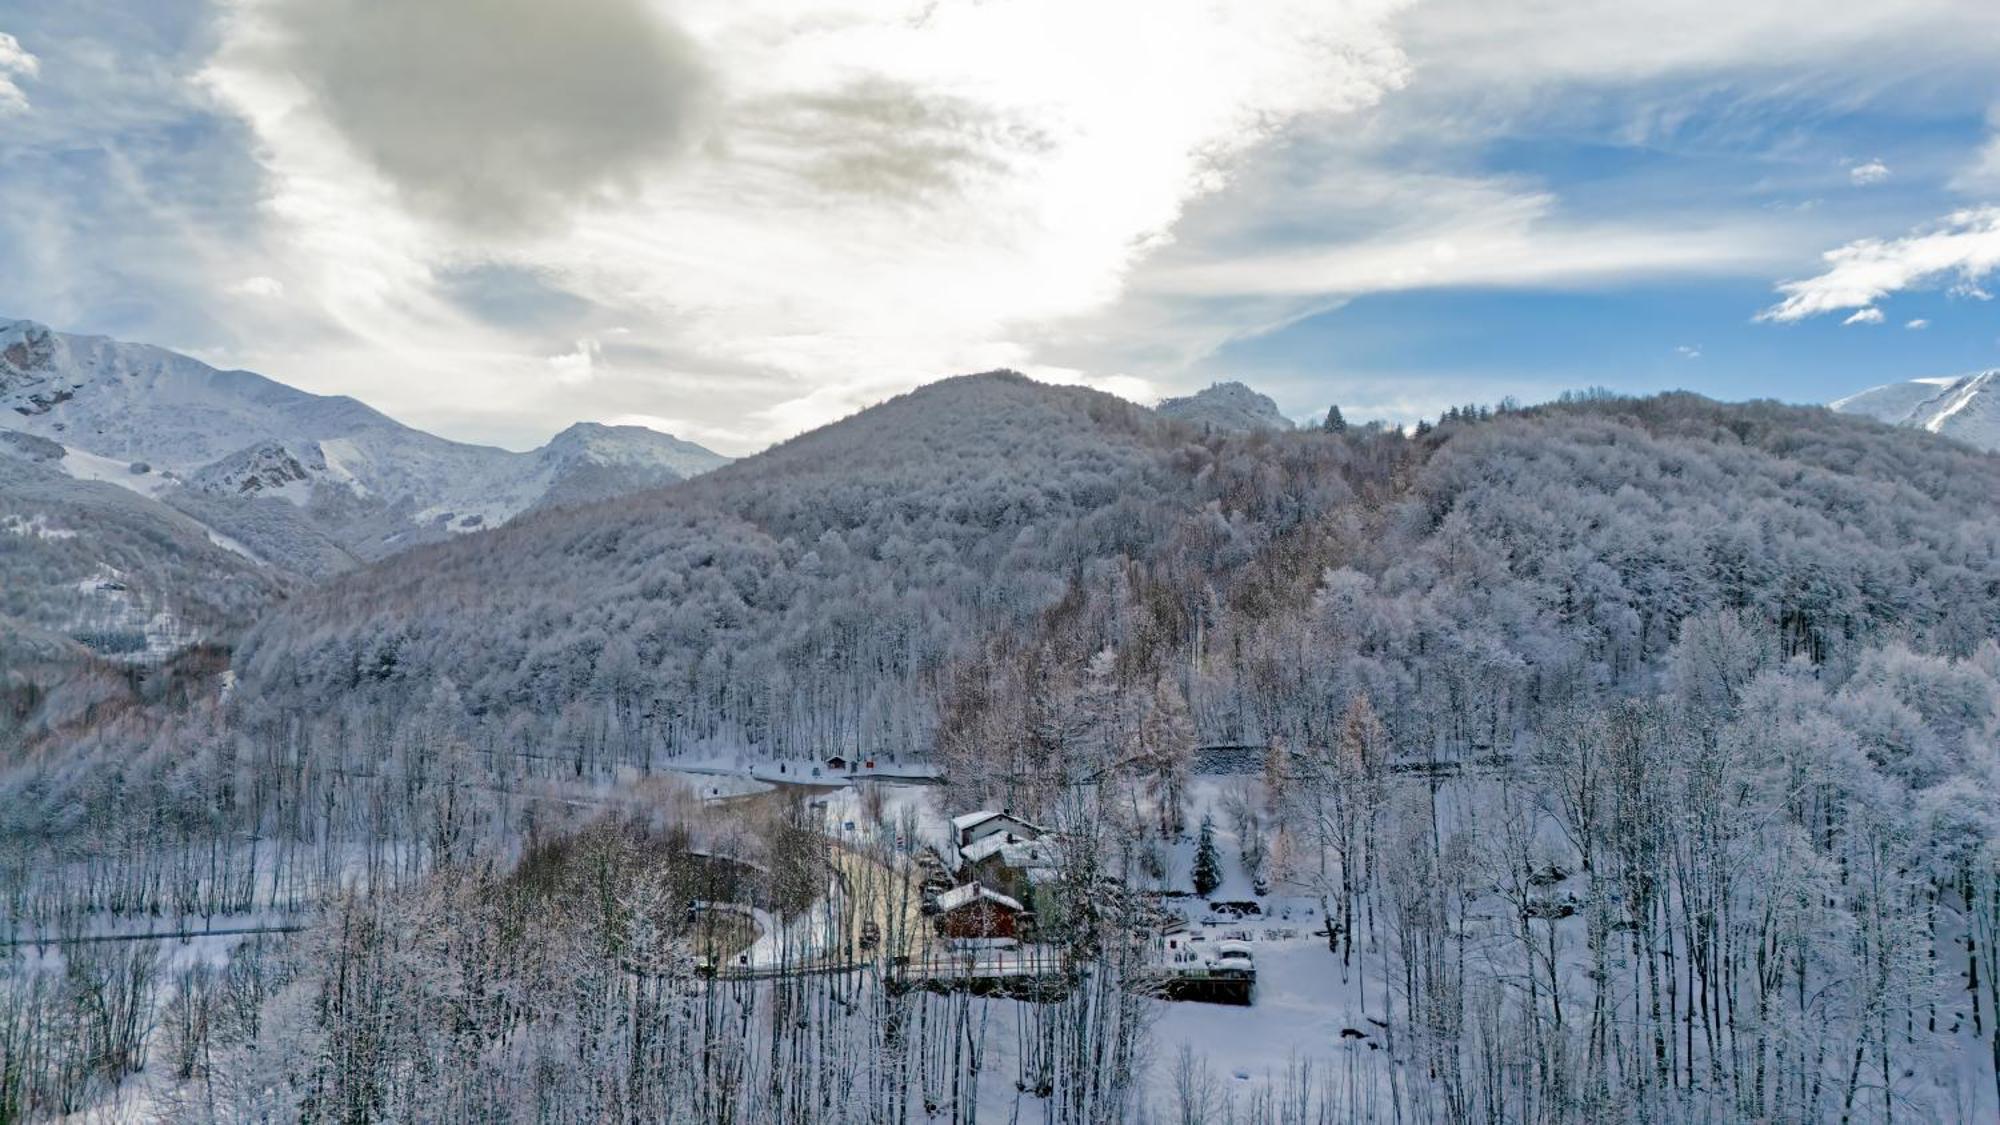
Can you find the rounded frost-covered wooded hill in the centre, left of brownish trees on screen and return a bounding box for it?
[240,374,1178,747]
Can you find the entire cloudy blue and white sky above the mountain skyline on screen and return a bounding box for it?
[0,0,2000,454]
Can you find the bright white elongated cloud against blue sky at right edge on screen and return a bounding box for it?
[1758,206,2000,322]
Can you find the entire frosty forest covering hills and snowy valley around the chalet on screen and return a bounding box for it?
[0,372,2000,1123]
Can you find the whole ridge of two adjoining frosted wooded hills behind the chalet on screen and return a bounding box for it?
[238,374,2000,768]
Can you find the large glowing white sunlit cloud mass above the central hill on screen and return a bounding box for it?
[204,0,1404,438]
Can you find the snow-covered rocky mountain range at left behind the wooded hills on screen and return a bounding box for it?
[0,320,728,575]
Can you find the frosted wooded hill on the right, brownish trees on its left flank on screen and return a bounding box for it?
[944,396,2000,796]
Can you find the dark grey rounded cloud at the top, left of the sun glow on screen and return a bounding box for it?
[284,0,708,232]
